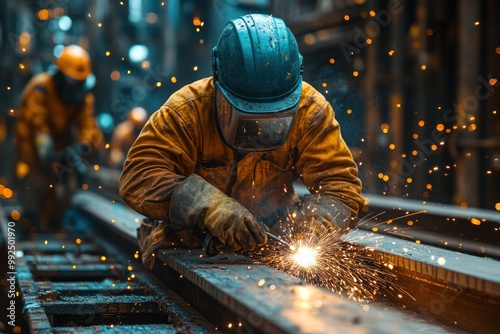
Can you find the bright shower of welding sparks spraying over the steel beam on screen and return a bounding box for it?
[253,214,411,301]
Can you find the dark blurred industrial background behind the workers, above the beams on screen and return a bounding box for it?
[0,0,500,234]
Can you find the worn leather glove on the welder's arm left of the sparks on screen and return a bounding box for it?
[169,174,267,251]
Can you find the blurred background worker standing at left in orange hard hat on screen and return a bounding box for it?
[15,45,102,237]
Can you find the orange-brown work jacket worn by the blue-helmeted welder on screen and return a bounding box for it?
[120,78,364,268]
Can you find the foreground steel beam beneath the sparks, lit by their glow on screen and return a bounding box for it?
[155,250,459,333]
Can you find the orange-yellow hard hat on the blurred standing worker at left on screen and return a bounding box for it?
[56,45,92,81]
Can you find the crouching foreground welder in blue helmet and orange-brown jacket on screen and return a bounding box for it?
[120,14,364,268]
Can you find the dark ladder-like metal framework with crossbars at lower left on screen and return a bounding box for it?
[13,236,214,333]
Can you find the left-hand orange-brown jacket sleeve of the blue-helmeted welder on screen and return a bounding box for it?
[120,106,197,220]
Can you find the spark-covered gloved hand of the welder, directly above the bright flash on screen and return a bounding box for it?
[294,194,351,238]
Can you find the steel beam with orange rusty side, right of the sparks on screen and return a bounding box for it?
[346,231,500,333]
